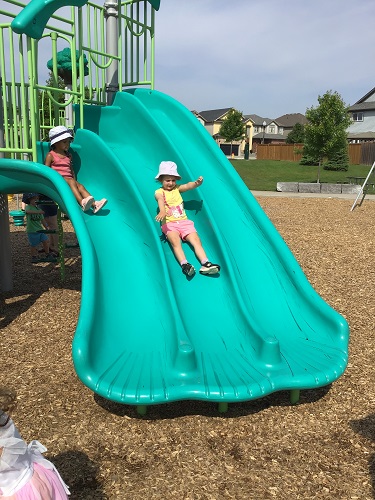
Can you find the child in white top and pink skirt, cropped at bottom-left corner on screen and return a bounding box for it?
[0,387,70,500]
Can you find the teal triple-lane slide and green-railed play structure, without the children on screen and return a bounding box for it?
[0,0,349,413]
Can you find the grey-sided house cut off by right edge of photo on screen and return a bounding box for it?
[347,88,375,143]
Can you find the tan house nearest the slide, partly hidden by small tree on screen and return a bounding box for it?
[197,108,253,156]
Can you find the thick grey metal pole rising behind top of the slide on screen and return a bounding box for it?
[104,0,119,106]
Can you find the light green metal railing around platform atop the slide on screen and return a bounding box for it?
[0,0,155,161]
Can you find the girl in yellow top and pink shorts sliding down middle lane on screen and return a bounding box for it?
[155,161,220,276]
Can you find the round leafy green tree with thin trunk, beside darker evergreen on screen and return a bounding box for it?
[303,90,350,182]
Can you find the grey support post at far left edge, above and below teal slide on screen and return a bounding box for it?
[0,77,13,292]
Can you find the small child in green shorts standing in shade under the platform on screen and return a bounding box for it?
[23,193,56,264]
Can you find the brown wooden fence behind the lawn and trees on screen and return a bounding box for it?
[257,142,375,165]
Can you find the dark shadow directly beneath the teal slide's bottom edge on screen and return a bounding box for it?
[94,385,331,420]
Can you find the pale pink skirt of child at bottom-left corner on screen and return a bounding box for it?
[0,462,68,500]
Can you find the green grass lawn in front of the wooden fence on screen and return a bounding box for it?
[230,160,375,193]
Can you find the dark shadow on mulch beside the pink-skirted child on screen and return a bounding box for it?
[51,451,107,500]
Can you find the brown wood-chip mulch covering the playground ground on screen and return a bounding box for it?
[0,197,375,500]
